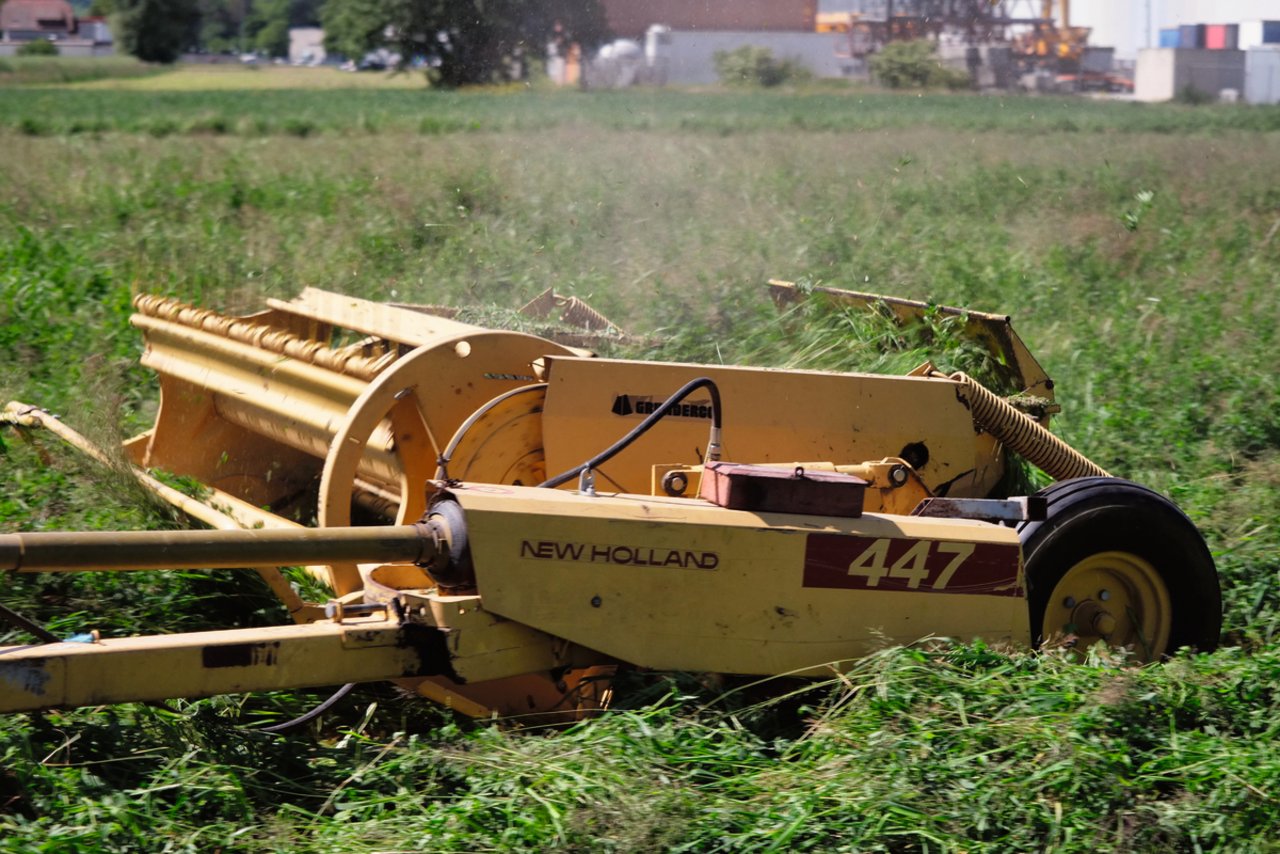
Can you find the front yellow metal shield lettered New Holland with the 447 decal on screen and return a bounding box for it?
[454,487,1029,673]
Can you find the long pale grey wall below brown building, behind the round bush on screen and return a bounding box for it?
[664,31,865,86]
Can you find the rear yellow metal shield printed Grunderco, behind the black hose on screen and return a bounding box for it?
[543,356,1004,497]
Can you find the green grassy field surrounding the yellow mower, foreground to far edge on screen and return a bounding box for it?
[0,69,1280,851]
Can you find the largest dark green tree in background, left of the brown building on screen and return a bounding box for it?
[320,0,608,86]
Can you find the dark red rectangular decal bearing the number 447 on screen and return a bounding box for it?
[804,534,1024,597]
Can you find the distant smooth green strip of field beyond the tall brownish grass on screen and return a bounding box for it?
[0,81,1280,136]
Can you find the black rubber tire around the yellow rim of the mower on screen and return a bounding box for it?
[1018,478,1222,658]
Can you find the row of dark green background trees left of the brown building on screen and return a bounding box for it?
[90,0,609,86]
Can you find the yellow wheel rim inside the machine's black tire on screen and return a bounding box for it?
[1041,552,1174,661]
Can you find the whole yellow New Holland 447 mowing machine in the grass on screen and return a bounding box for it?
[0,283,1221,716]
